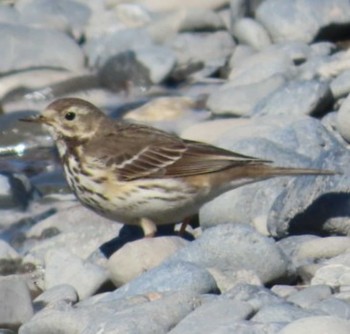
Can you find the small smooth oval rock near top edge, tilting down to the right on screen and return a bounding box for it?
[232,18,271,50]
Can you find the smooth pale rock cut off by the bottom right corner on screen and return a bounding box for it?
[279,316,350,334]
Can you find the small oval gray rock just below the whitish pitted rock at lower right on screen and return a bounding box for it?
[287,285,332,308]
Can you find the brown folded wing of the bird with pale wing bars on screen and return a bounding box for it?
[86,124,269,181]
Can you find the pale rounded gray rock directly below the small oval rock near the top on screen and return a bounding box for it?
[229,49,295,85]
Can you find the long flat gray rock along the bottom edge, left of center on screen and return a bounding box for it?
[19,291,201,334]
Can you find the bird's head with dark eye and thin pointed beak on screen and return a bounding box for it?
[22,98,105,139]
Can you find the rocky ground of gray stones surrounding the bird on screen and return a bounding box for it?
[0,0,350,334]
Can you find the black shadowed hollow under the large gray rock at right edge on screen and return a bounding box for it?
[288,193,350,237]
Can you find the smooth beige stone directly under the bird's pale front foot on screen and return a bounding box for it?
[108,237,188,286]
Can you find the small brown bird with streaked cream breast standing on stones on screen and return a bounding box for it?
[22,97,335,237]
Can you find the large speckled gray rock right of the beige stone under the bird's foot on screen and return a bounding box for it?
[167,224,287,283]
